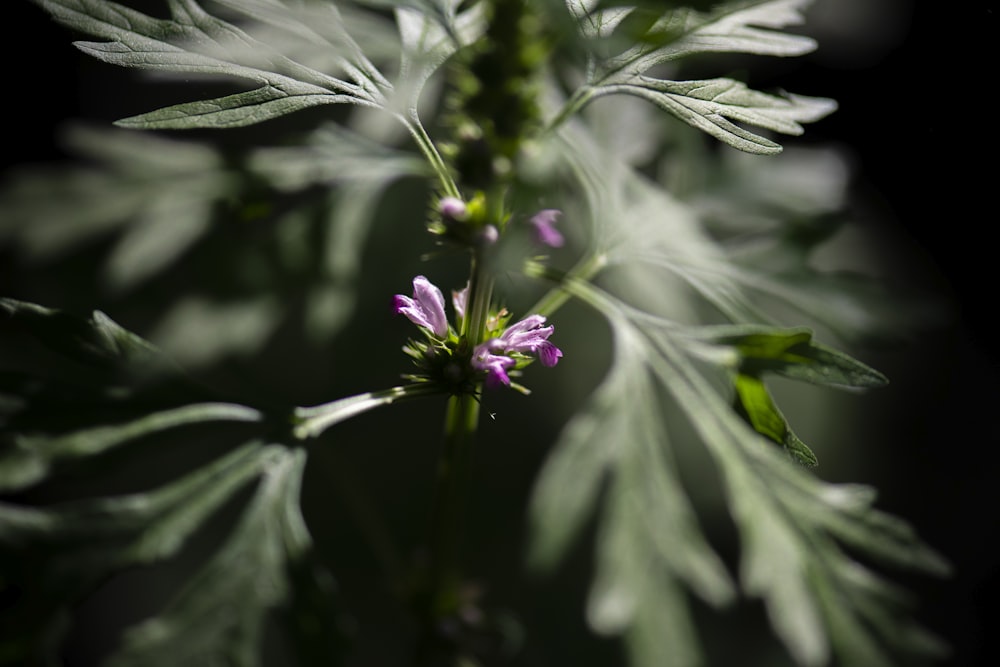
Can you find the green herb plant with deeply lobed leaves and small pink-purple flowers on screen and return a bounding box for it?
[0,0,948,667]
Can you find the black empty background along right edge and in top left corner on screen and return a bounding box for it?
[0,0,1000,666]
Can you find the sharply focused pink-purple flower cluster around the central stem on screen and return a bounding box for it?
[393,276,563,392]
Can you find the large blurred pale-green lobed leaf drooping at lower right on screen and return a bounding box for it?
[531,281,947,666]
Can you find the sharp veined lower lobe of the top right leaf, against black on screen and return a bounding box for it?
[595,77,837,155]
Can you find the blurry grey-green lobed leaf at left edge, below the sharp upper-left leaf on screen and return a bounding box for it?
[0,126,232,278]
